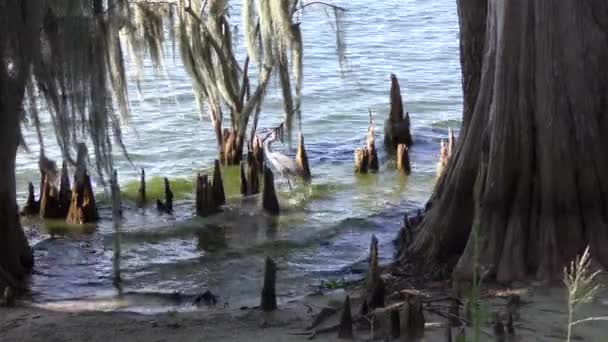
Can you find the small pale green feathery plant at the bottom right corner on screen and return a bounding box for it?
[564,246,608,342]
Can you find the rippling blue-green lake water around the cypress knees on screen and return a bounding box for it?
[17,0,462,312]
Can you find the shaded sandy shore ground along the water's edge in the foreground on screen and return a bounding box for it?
[0,286,608,342]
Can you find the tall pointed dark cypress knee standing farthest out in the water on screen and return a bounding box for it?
[384,74,413,151]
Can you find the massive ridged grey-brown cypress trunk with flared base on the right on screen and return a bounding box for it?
[411,0,608,282]
